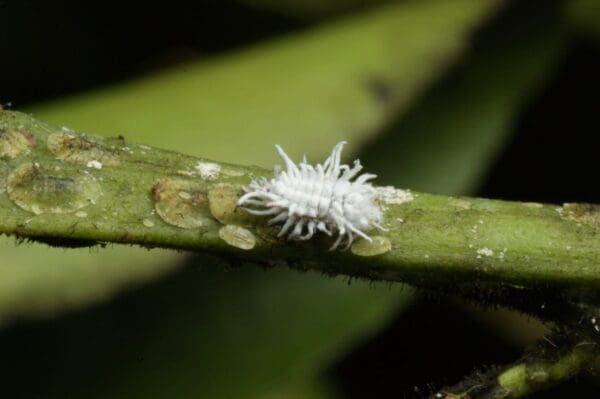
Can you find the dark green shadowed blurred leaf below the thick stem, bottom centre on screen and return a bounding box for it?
[0,257,410,398]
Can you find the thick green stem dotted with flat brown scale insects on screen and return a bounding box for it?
[0,111,600,290]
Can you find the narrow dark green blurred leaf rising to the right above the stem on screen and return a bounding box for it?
[361,0,567,195]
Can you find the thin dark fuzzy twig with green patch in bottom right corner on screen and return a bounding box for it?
[431,289,600,399]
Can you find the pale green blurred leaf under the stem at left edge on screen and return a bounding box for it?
[0,241,181,327]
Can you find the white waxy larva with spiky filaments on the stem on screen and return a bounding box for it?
[238,141,385,250]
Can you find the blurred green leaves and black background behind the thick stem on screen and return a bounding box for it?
[0,0,600,398]
